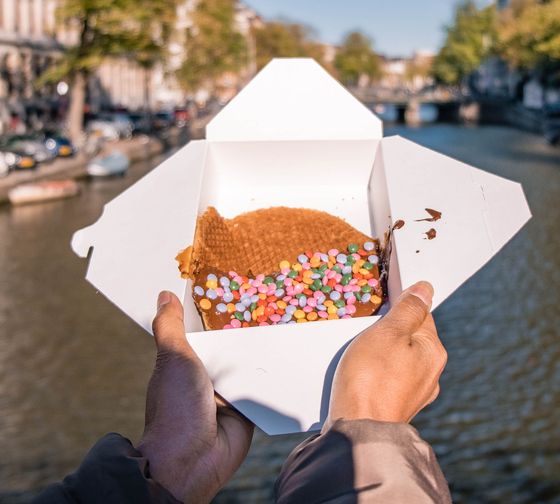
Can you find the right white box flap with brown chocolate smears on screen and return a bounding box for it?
[374,136,531,308]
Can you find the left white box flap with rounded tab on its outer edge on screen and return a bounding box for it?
[72,140,206,332]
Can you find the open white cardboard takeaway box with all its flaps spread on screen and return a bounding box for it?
[72,59,530,434]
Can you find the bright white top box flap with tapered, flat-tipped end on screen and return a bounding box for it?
[206,58,383,141]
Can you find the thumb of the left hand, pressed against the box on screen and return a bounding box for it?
[152,291,190,353]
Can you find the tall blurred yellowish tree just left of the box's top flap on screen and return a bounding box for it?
[177,0,247,91]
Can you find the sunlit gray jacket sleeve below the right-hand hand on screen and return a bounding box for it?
[275,420,451,504]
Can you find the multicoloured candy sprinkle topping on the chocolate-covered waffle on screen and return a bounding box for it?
[193,241,383,329]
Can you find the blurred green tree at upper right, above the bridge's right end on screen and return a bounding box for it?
[433,0,497,84]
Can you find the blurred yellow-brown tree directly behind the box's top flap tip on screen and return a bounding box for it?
[254,21,324,70]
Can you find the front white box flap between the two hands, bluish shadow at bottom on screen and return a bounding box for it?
[187,317,379,434]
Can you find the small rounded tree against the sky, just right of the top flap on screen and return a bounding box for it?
[334,31,382,86]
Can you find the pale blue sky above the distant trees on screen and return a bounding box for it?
[245,0,490,56]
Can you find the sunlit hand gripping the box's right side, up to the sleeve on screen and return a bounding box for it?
[324,282,447,429]
